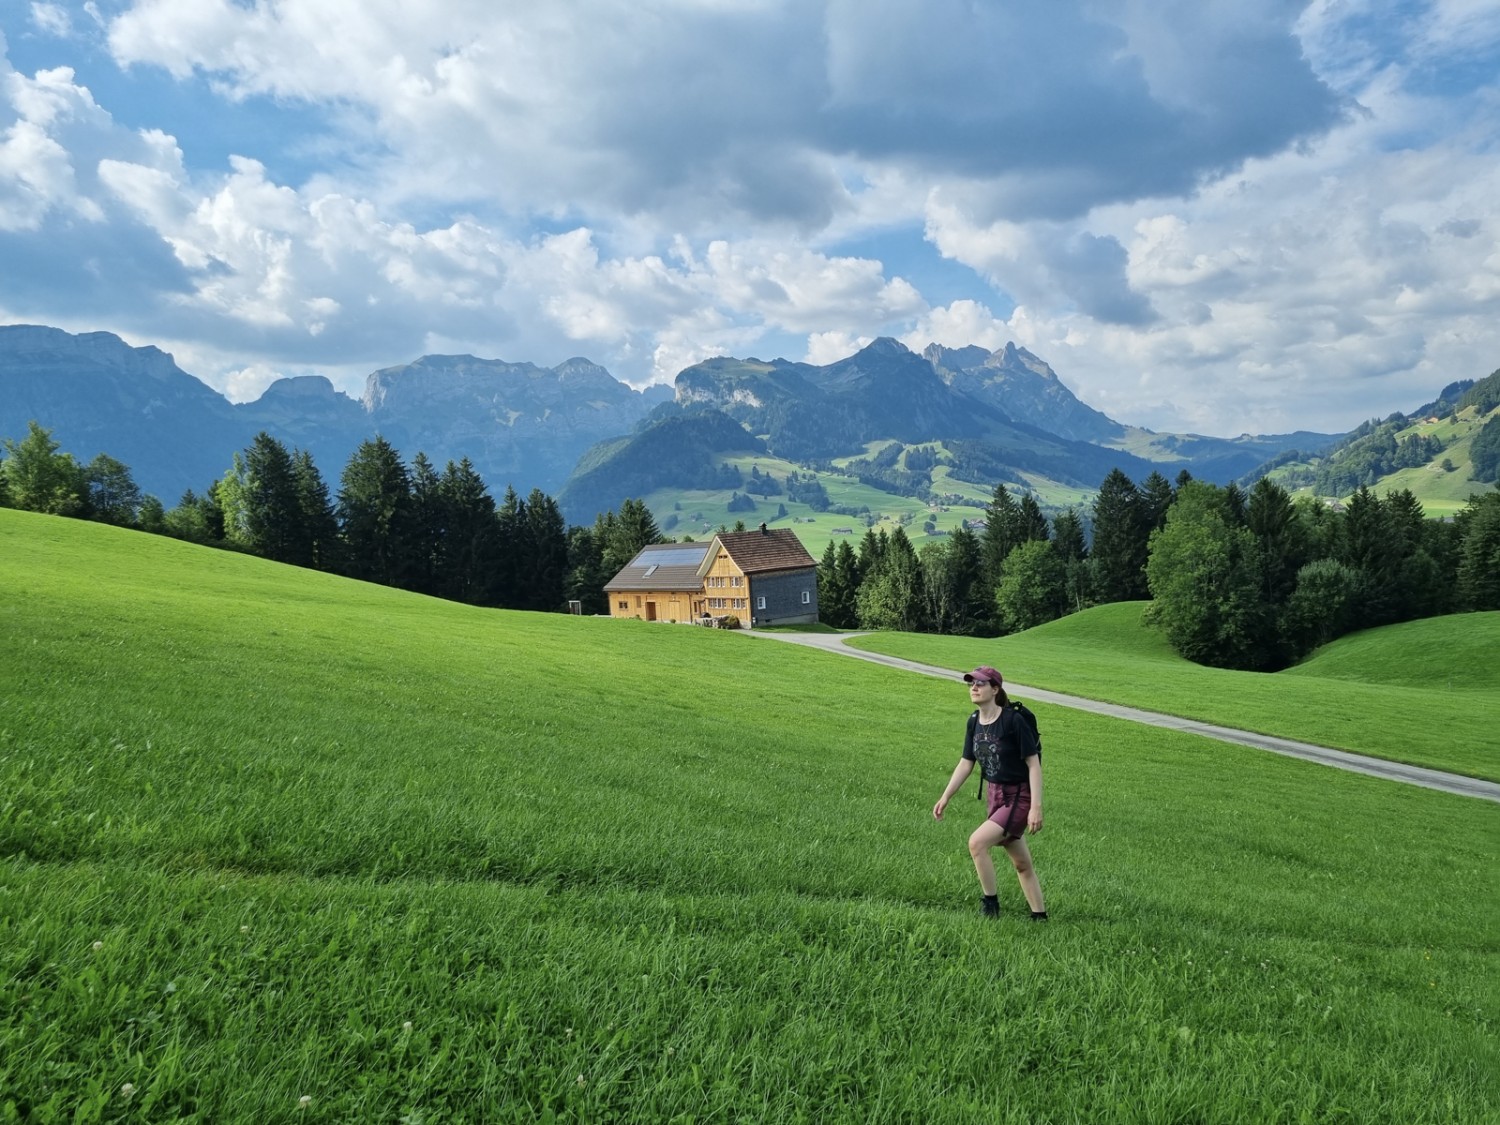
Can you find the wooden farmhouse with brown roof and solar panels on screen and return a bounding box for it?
[605,524,818,627]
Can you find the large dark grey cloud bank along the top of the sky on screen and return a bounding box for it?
[110,0,1343,231]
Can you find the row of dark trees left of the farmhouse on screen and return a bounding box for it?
[0,422,662,614]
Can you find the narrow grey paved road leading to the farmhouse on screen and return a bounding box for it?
[744,629,1500,803]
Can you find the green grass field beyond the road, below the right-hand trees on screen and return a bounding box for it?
[849,602,1500,782]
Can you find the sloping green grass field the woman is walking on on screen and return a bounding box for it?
[0,510,1500,1125]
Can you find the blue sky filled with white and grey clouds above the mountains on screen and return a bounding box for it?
[0,0,1500,435]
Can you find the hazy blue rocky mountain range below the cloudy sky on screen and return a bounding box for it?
[0,326,1340,522]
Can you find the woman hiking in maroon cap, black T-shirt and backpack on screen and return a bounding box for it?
[933,666,1047,923]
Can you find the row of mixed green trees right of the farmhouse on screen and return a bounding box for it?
[818,470,1500,671]
